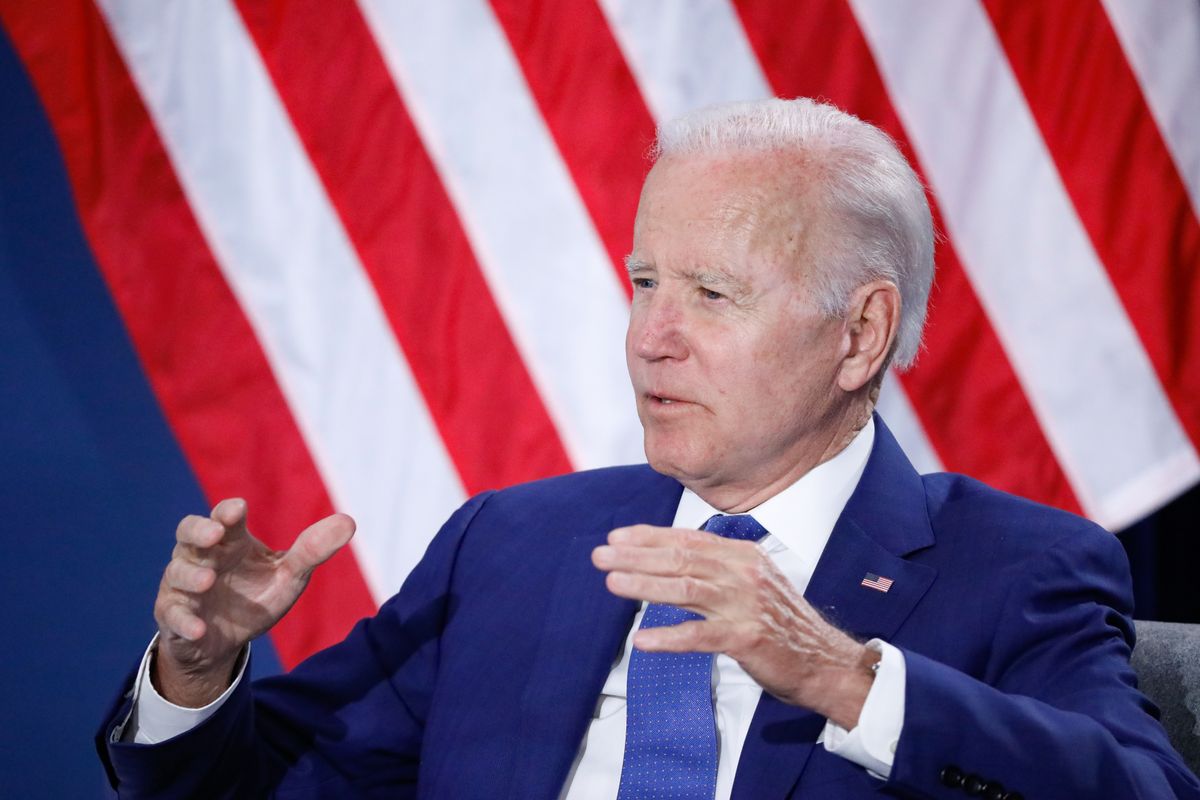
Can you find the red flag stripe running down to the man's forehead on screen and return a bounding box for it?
[492,0,654,296]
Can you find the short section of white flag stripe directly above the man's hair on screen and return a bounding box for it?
[600,0,772,122]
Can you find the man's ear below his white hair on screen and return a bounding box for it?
[838,279,900,392]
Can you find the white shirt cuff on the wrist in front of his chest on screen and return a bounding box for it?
[821,639,907,780]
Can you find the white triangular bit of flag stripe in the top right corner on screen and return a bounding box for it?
[1103,0,1200,216]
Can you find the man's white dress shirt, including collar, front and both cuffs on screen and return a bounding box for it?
[124,421,905,800]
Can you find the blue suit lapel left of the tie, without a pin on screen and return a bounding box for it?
[510,469,683,798]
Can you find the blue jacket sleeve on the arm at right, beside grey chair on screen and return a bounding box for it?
[888,531,1200,800]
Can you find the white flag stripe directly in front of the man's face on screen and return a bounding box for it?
[361,0,644,468]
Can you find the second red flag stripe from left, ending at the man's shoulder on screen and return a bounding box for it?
[236,0,571,493]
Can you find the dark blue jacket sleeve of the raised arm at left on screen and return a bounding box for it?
[96,494,490,799]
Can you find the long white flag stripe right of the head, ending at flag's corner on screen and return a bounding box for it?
[851,0,1200,528]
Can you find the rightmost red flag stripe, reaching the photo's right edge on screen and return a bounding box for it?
[984,0,1200,446]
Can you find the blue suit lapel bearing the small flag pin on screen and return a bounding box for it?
[733,416,936,800]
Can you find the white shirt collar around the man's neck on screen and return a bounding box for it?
[674,417,875,565]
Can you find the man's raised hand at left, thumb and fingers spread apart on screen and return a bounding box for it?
[154,499,354,708]
